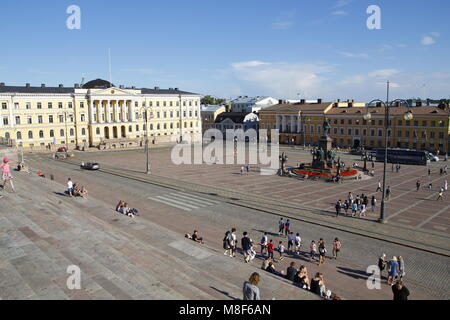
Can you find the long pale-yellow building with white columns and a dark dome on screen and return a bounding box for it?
[0,79,202,149]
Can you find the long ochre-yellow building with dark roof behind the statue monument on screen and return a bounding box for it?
[260,100,450,153]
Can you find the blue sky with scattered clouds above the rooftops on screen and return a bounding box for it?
[0,0,450,101]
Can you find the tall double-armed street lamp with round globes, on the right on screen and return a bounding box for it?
[363,99,414,223]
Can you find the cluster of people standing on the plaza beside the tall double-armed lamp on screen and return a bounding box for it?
[335,188,376,217]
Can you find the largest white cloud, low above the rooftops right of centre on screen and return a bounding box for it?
[231,61,333,97]
